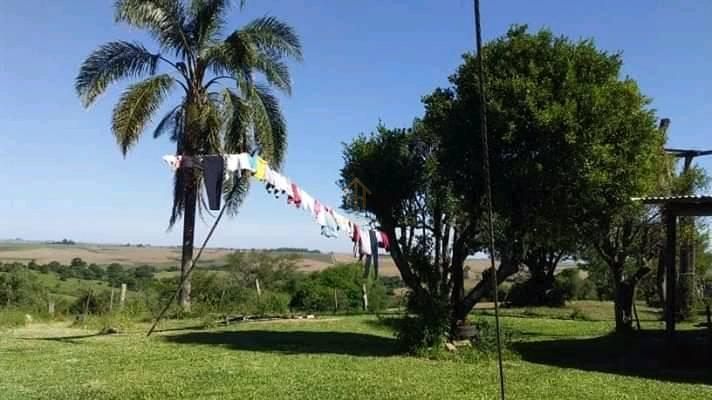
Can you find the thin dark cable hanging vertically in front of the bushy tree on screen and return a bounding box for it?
[474,0,505,400]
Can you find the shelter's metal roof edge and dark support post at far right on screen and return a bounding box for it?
[635,196,712,341]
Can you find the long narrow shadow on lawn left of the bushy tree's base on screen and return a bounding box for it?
[163,330,397,357]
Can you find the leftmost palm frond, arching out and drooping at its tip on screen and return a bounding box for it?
[74,41,160,107]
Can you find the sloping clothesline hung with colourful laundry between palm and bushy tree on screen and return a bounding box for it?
[163,153,390,276]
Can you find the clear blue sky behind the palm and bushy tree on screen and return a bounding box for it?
[0,0,712,251]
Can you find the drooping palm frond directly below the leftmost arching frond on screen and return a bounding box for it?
[111,74,175,156]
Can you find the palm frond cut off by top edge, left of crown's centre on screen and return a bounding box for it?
[115,0,191,54]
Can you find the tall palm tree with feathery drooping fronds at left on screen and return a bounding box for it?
[75,0,302,310]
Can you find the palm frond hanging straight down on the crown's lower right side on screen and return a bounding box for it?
[250,84,287,168]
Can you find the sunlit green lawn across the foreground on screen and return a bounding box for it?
[0,303,712,400]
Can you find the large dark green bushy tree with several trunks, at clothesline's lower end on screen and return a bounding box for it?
[340,26,664,344]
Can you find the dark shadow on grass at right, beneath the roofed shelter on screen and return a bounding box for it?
[513,330,712,385]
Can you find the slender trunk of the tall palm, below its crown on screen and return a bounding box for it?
[179,162,198,312]
